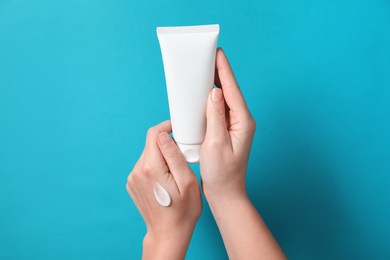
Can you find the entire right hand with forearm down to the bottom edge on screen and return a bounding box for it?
[200,49,286,259]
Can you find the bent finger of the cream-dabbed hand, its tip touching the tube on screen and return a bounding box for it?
[143,120,172,168]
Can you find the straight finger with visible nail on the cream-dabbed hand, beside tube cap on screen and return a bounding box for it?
[158,132,195,192]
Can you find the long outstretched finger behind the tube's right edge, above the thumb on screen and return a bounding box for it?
[215,48,249,113]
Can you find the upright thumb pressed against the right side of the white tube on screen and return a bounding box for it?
[205,88,228,143]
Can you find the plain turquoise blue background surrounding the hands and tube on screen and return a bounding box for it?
[0,0,390,259]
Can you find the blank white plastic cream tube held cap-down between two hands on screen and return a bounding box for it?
[157,24,219,163]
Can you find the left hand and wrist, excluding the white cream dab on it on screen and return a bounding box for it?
[126,121,202,259]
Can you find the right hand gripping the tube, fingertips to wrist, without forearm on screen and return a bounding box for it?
[200,49,256,200]
